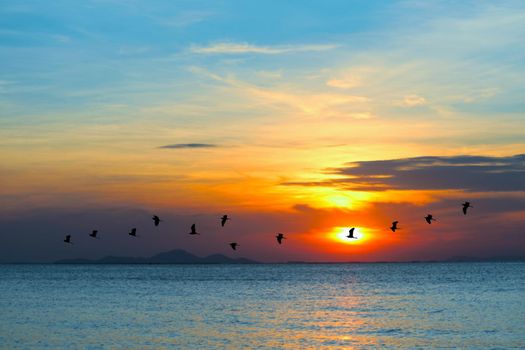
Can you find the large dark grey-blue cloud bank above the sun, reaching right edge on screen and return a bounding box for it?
[284,154,525,192]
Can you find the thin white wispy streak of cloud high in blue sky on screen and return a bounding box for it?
[190,42,337,55]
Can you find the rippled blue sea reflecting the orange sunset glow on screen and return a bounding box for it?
[0,263,525,349]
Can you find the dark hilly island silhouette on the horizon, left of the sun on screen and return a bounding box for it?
[55,249,258,264]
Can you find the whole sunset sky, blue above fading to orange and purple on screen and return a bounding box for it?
[0,0,525,262]
